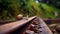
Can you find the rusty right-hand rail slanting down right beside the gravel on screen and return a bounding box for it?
[39,18,53,34]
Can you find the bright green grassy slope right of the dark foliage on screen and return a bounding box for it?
[24,0,60,18]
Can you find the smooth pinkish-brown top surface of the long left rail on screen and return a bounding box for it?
[0,16,36,34]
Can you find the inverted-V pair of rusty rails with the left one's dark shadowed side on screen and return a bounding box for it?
[0,16,52,34]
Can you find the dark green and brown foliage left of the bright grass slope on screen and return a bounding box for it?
[0,0,35,19]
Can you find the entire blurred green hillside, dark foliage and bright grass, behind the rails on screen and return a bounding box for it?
[0,0,60,20]
